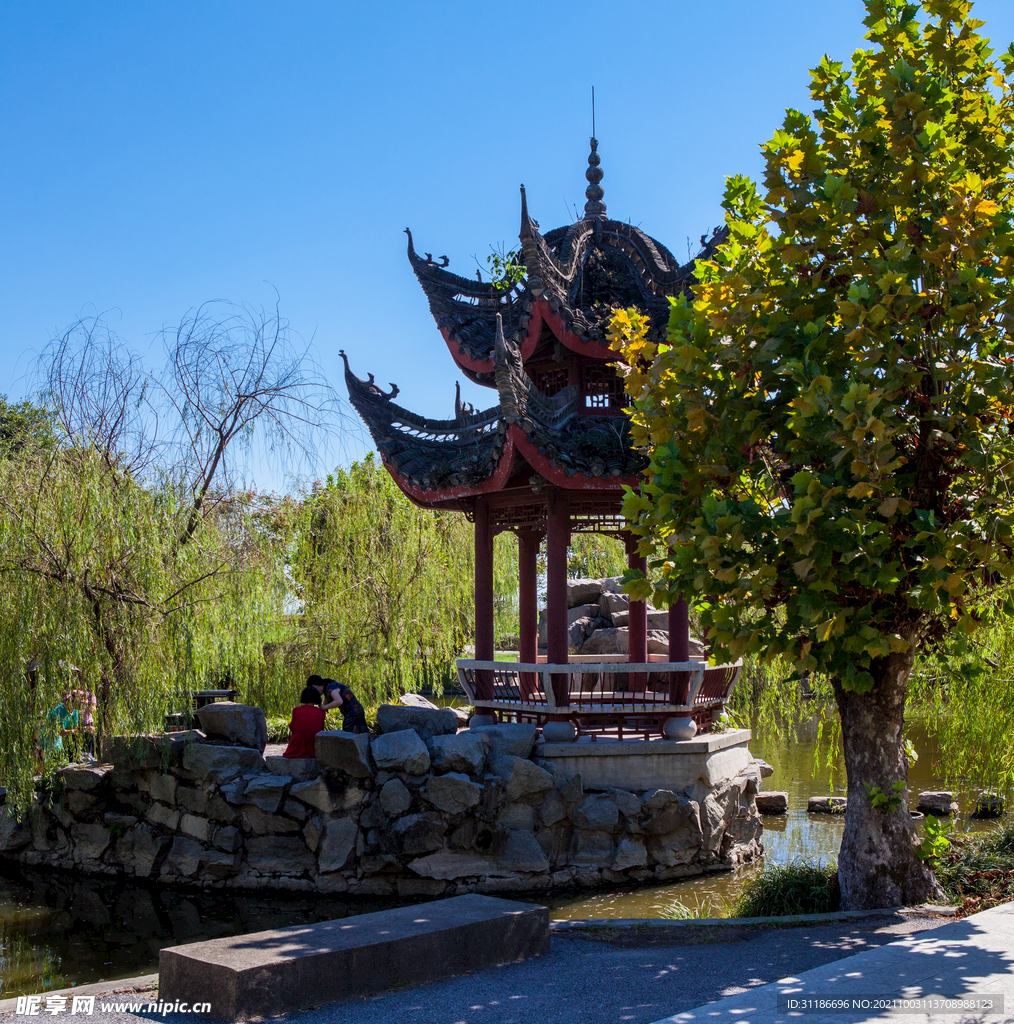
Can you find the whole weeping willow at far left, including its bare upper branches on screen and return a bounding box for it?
[0,306,338,807]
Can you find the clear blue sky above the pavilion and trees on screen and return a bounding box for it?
[0,0,1014,484]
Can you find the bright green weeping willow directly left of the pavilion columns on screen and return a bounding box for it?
[286,454,517,705]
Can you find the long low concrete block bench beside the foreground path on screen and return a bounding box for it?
[159,895,549,1021]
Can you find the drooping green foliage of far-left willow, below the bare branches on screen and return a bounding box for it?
[0,446,286,805]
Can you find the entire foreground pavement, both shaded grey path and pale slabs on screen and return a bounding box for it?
[0,904,1014,1024]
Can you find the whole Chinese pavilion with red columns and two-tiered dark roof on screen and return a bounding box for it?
[341,138,737,735]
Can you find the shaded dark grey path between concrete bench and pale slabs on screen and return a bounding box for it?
[0,918,941,1024]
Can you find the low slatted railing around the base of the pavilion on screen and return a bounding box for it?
[457,659,743,738]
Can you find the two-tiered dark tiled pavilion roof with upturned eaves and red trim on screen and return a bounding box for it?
[341,138,724,514]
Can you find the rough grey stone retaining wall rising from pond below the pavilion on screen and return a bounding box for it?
[0,708,762,896]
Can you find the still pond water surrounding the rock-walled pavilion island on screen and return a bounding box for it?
[0,723,1010,997]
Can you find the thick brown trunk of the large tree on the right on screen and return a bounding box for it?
[834,653,941,910]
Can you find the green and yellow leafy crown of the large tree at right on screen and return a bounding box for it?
[611,0,1014,691]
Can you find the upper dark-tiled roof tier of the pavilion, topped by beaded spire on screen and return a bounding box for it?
[406,138,726,372]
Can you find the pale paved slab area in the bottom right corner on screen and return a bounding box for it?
[654,903,1014,1024]
